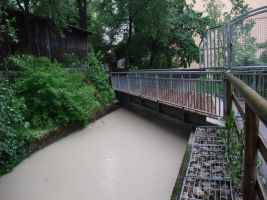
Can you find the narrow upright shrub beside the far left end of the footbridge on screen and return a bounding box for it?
[82,51,115,108]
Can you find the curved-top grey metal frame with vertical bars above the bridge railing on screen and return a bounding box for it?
[199,6,267,69]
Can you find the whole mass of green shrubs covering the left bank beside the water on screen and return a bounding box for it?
[0,53,114,174]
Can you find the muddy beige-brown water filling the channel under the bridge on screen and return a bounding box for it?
[0,106,191,200]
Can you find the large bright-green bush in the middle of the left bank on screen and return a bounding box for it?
[12,55,100,128]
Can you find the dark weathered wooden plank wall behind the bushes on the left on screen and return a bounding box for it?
[0,11,90,61]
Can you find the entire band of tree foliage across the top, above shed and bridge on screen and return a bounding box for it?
[0,0,253,68]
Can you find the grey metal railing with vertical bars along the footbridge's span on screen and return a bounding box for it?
[111,71,224,117]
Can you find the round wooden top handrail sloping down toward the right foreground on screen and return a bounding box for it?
[224,71,267,125]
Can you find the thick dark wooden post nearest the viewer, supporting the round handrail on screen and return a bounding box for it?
[243,103,259,200]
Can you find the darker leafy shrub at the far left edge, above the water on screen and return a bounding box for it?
[0,80,27,174]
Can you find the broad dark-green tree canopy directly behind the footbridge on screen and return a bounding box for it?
[99,0,210,68]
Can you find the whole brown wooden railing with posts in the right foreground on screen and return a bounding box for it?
[225,72,267,200]
